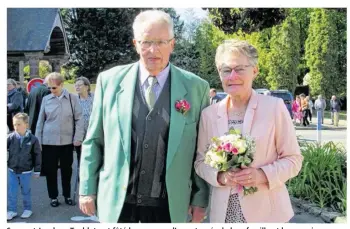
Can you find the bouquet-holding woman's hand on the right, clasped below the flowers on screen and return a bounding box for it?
[233,168,268,187]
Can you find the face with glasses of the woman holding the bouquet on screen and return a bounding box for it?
[218,53,258,96]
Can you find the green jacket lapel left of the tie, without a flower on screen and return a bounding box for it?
[115,63,139,163]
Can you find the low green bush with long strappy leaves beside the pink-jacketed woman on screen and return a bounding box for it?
[287,142,347,214]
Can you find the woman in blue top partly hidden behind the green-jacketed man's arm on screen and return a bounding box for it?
[74,77,94,166]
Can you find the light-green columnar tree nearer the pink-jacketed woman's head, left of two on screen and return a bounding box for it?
[266,16,300,92]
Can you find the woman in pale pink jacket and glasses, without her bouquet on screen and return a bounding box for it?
[195,40,303,223]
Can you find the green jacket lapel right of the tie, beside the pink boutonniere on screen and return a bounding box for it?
[166,64,187,169]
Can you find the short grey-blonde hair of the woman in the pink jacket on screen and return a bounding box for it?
[215,39,258,69]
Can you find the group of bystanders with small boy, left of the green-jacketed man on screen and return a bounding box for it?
[7,72,94,220]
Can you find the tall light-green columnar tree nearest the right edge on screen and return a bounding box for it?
[305,9,346,98]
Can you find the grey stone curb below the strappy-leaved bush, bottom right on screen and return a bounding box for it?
[290,196,346,223]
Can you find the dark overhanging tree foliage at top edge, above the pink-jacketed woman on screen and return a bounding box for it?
[209,8,286,33]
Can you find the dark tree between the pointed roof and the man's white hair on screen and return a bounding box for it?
[62,8,149,78]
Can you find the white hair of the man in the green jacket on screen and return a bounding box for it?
[132,10,174,39]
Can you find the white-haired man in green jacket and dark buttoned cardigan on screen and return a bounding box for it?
[79,10,209,223]
